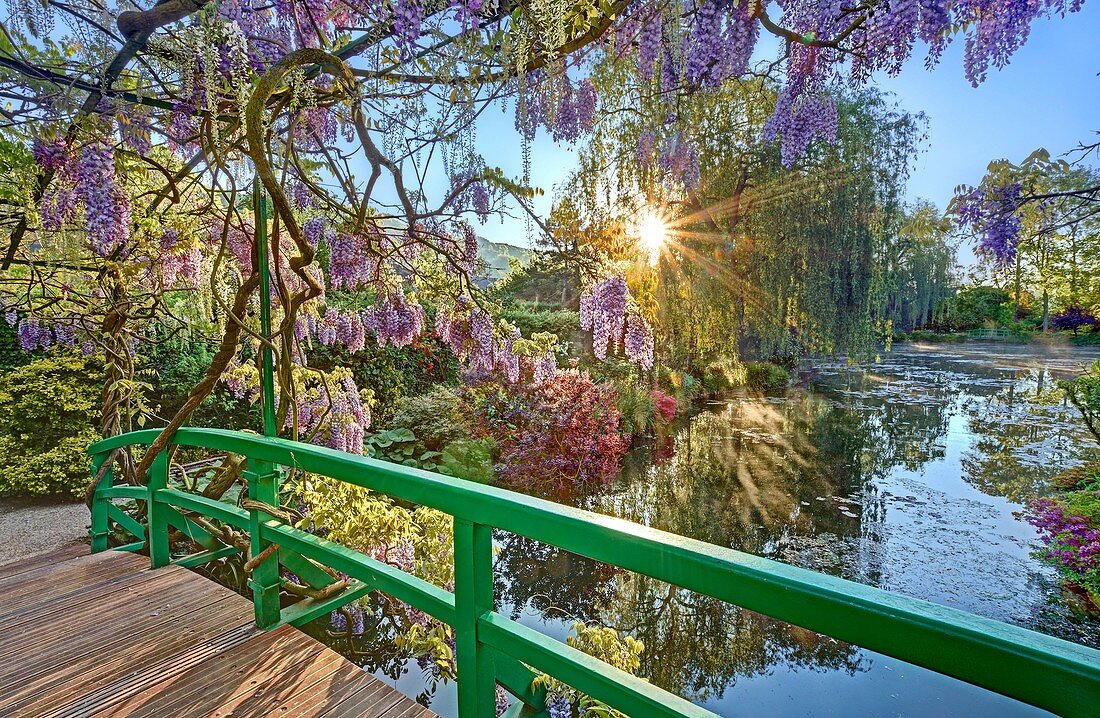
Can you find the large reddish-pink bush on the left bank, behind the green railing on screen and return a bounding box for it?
[462,371,627,495]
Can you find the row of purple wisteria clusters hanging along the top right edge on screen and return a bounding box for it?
[616,0,1082,165]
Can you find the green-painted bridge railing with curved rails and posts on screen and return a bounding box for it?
[90,429,1100,718]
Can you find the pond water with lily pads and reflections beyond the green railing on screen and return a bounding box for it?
[310,343,1100,718]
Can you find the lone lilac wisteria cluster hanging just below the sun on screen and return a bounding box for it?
[581,275,653,371]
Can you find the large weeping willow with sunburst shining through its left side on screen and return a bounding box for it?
[556,72,924,366]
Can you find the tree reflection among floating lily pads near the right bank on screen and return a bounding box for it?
[961,368,1090,504]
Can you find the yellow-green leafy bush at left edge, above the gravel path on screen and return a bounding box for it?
[0,354,102,496]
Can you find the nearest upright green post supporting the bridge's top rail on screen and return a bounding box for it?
[454,519,496,718]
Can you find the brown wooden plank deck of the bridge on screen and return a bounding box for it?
[0,546,435,718]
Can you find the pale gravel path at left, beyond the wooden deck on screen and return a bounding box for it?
[0,498,90,564]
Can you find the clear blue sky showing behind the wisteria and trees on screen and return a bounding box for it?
[470,0,1100,249]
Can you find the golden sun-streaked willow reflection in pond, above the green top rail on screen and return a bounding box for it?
[607,393,906,573]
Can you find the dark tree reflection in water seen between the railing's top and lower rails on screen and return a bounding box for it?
[495,534,866,700]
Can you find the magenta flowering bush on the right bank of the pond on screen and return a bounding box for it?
[1026,489,1100,597]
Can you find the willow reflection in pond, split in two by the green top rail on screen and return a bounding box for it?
[496,395,883,699]
